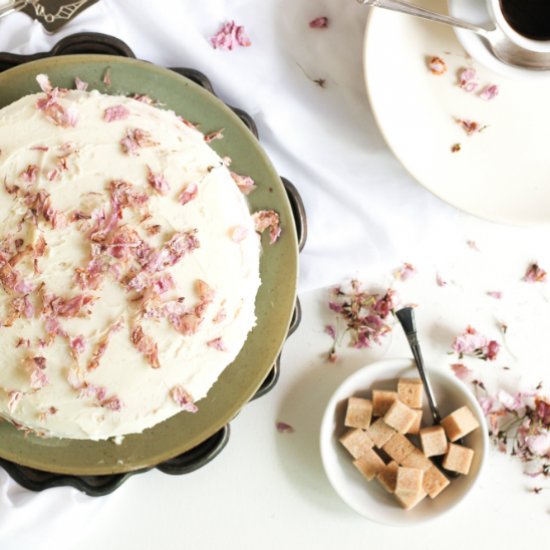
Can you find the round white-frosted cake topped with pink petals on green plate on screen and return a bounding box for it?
[0,75,270,440]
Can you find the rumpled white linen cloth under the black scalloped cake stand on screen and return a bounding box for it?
[0,0,548,550]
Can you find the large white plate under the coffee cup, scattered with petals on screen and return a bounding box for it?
[364,0,550,225]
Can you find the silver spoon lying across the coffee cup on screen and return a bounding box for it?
[357,0,550,71]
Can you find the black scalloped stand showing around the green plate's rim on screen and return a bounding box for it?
[0,33,307,496]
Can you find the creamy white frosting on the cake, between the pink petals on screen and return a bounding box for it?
[0,91,260,439]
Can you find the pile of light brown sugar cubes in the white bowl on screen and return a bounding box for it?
[340,378,479,510]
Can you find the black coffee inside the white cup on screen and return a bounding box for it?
[500,0,550,40]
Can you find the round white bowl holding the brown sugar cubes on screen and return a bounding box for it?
[321,359,488,525]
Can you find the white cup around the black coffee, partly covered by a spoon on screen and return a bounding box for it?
[448,0,550,81]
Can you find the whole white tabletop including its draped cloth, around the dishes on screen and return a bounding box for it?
[0,0,550,550]
